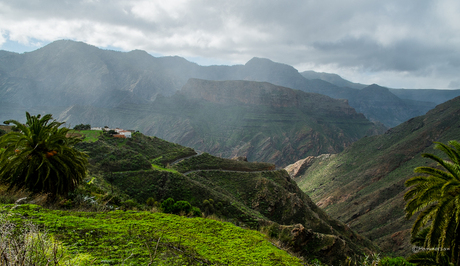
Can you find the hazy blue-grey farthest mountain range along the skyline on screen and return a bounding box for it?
[0,40,460,130]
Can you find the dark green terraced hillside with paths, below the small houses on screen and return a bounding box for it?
[52,129,376,265]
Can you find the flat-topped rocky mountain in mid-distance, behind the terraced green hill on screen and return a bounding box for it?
[64,79,384,166]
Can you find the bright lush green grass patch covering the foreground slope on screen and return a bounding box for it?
[0,205,302,265]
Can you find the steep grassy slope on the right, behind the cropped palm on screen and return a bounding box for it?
[296,95,460,255]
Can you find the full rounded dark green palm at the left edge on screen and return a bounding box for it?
[0,113,88,196]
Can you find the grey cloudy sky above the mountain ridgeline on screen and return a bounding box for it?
[0,0,460,89]
